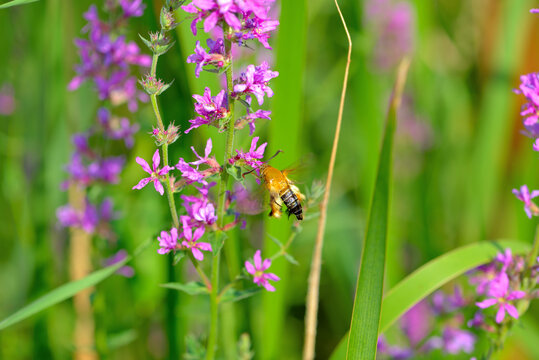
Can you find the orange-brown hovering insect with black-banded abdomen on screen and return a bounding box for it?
[244,164,305,220]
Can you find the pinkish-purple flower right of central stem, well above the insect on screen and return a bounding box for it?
[233,61,279,105]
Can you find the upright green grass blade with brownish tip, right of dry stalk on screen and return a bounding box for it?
[346,60,409,360]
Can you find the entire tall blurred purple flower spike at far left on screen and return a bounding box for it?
[57,0,151,261]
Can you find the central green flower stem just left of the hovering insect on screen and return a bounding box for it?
[206,25,234,360]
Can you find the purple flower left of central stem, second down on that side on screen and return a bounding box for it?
[185,87,229,134]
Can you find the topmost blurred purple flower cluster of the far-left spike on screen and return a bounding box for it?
[68,0,151,111]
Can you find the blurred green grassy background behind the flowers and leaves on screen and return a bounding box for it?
[0,0,539,359]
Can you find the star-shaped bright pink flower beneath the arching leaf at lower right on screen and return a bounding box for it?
[475,272,526,324]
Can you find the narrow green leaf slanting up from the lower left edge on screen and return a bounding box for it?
[0,257,131,330]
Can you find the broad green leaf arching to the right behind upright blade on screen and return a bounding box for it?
[331,240,530,360]
